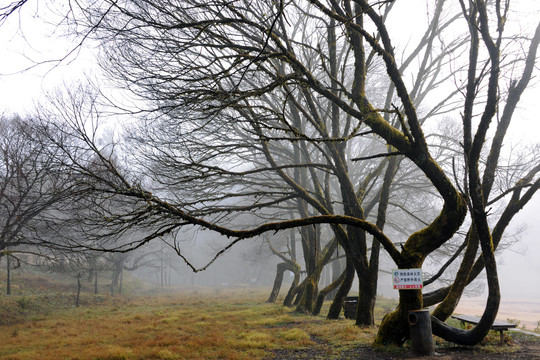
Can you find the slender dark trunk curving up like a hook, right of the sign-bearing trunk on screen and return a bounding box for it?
[426,0,506,345]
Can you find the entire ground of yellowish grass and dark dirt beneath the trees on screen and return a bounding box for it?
[0,274,540,360]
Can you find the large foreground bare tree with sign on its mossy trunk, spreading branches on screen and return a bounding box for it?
[10,0,540,344]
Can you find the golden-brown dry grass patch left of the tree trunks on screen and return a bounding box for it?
[0,289,382,360]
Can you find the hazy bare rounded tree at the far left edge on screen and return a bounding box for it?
[0,117,77,294]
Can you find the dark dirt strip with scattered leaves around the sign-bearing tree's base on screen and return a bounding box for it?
[265,338,540,360]
